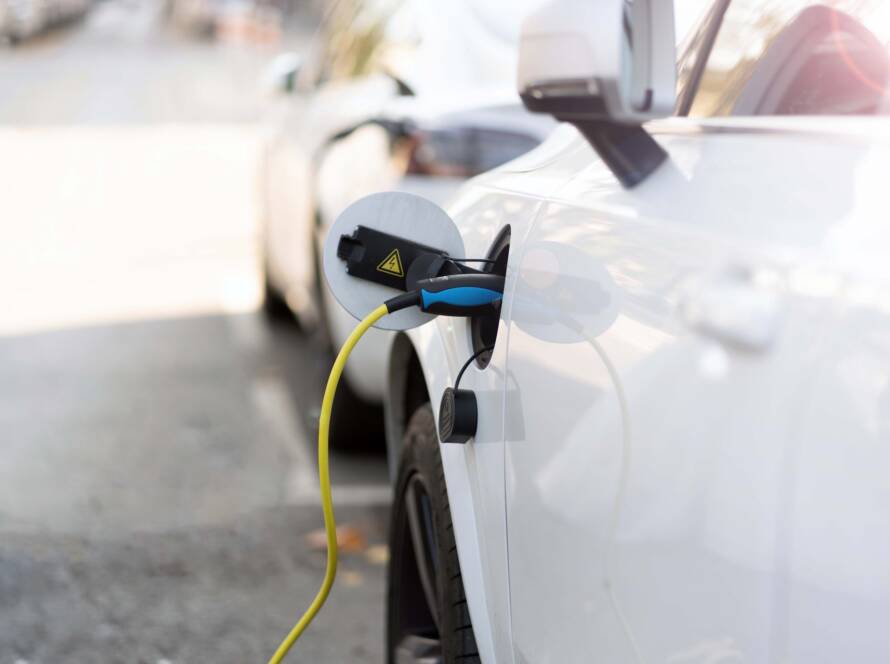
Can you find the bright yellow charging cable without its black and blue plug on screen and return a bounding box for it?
[269,304,390,664]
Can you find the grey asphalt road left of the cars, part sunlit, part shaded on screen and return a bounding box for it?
[0,0,389,664]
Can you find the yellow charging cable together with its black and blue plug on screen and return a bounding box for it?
[269,273,504,664]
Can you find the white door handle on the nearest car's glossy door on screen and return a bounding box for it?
[680,268,786,352]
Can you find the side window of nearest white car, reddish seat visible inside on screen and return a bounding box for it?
[690,0,890,117]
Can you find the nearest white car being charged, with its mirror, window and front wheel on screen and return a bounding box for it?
[386,0,890,664]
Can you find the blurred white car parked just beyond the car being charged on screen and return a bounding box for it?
[253,0,554,445]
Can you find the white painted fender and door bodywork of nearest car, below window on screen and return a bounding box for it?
[392,118,890,663]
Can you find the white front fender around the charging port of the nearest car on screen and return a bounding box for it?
[389,148,578,663]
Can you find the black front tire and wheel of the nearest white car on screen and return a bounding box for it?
[386,404,480,664]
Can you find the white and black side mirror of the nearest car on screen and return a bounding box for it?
[517,0,676,187]
